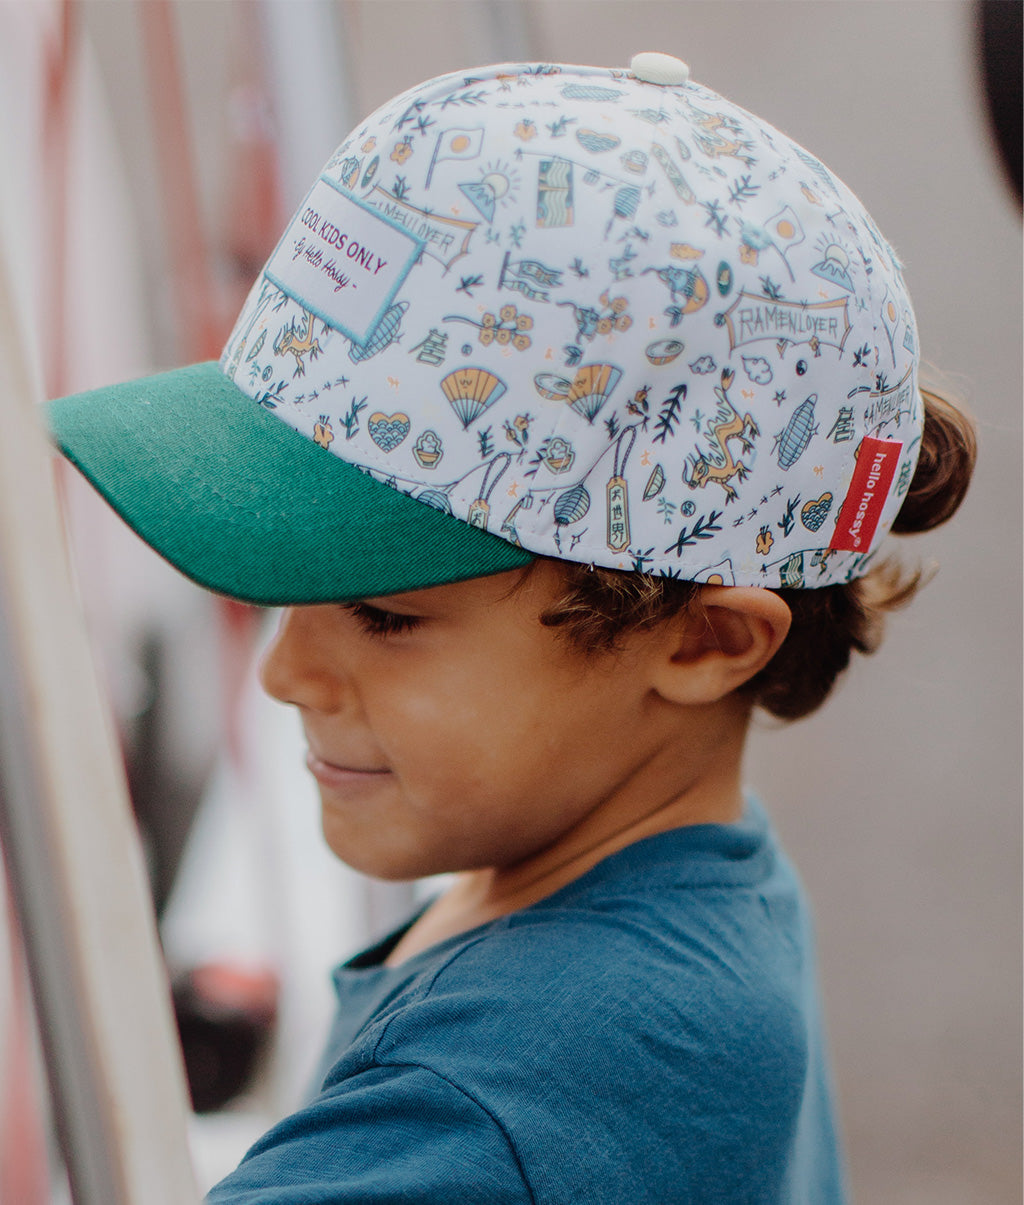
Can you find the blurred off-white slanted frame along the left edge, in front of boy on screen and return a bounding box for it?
[0,143,198,1205]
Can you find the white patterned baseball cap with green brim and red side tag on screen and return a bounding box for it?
[49,54,923,605]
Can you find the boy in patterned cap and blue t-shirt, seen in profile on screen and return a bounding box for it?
[52,54,972,1203]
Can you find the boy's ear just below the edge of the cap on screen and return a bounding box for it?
[654,586,791,705]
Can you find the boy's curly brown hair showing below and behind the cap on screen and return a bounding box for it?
[527,389,977,719]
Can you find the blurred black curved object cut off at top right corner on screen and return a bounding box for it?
[978,0,1024,204]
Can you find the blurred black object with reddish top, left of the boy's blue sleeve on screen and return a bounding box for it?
[172,964,278,1113]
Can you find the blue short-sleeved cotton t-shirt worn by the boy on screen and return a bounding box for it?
[208,803,844,1205]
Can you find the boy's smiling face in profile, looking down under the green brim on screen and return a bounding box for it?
[261,562,684,878]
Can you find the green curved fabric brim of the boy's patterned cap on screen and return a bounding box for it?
[47,363,532,606]
